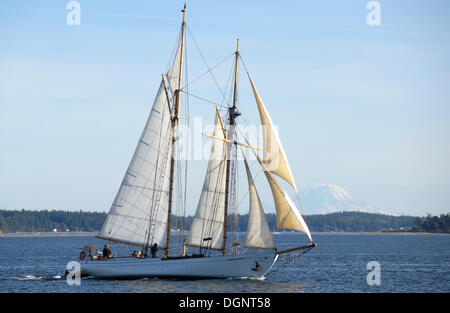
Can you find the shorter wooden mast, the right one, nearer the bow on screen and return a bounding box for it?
[222,38,239,255]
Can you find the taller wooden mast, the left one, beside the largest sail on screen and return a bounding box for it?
[165,3,186,256]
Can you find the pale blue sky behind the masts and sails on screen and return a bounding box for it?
[0,0,450,215]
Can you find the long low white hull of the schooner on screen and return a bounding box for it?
[81,251,278,279]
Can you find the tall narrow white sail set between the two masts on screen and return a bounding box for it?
[188,112,227,250]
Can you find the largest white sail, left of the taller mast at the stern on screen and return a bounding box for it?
[98,78,172,246]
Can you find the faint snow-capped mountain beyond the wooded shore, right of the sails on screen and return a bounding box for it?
[300,184,392,215]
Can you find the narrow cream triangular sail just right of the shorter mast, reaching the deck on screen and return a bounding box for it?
[244,157,275,249]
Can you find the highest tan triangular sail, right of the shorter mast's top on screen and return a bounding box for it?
[248,75,297,192]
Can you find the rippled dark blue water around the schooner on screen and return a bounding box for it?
[0,233,450,293]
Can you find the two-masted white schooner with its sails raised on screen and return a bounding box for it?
[81,6,316,279]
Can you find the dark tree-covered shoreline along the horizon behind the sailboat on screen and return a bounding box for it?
[0,210,450,233]
